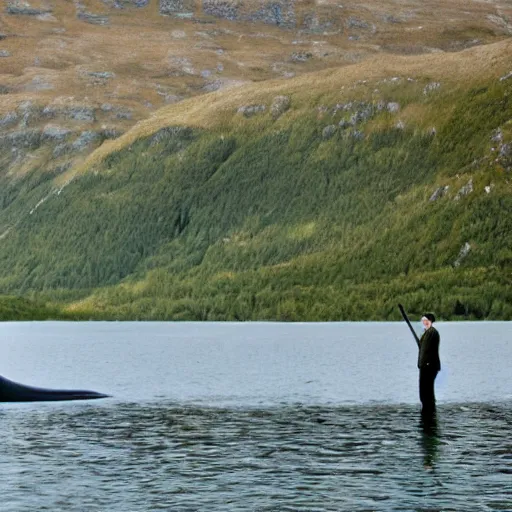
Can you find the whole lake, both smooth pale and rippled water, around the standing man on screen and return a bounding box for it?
[0,322,512,512]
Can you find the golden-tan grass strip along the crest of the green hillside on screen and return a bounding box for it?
[78,38,512,172]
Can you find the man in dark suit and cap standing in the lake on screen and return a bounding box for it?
[418,313,441,416]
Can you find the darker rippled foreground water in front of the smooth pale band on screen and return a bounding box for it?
[0,400,512,512]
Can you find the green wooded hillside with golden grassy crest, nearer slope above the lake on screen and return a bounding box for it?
[0,40,512,320]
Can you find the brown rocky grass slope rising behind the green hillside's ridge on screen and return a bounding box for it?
[0,0,512,184]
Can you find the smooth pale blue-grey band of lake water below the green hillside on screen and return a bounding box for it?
[0,322,512,406]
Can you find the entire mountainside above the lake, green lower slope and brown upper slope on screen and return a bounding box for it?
[0,0,512,320]
